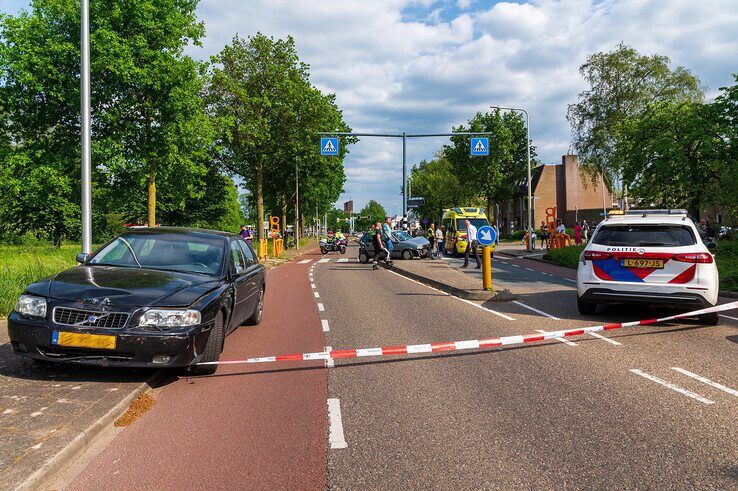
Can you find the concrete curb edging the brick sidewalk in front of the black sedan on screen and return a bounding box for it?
[15,371,164,490]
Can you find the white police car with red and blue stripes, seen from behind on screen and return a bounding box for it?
[577,210,719,325]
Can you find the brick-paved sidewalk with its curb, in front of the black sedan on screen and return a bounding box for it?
[0,320,160,489]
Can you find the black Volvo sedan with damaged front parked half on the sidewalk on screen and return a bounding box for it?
[8,228,265,373]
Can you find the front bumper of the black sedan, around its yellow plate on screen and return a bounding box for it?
[8,312,211,367]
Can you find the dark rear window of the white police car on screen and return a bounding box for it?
[592,225,696,247]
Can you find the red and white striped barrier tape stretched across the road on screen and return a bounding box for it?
[198,301,738,365]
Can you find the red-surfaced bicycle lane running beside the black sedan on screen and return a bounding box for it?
[70,254,328,489]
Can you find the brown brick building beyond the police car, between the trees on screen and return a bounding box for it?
[498,155,613,233]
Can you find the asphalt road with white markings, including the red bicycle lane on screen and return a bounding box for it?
[66,244,738,489]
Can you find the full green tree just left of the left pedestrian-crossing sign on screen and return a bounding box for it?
[208,34,346,242]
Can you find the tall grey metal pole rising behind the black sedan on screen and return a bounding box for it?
[80,0,92,254]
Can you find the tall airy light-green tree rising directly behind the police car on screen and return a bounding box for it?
[567,43,703,205]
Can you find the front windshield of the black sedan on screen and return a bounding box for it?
[88,233,225,275]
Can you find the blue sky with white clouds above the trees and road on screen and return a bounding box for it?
[0,0,738,213]
